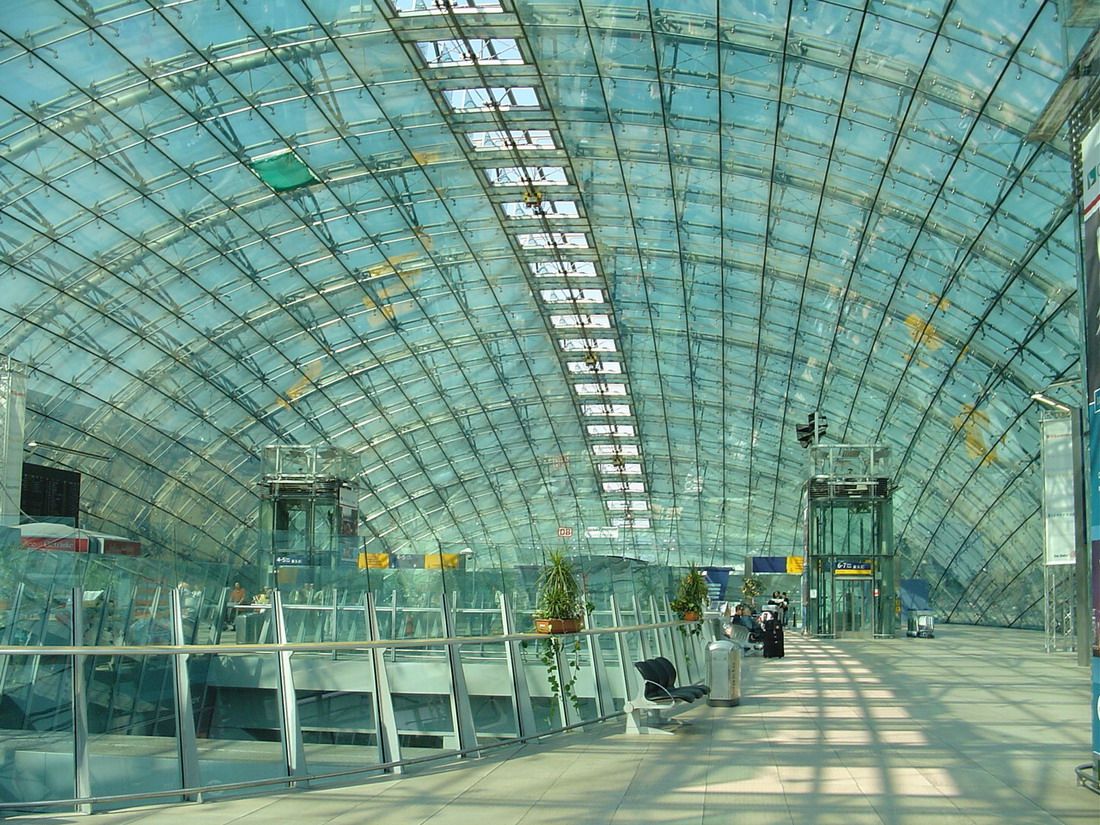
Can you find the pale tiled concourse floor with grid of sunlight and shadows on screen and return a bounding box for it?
[10,626,1100,825]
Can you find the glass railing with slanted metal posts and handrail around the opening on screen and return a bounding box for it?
[0,585,704,815]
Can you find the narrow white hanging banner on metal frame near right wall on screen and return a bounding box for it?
[1042,416,1077,564]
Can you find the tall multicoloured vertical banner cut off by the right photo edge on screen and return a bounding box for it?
[1081,114,1100,770]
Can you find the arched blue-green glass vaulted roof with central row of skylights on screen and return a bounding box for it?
[0,0,1089,624]
